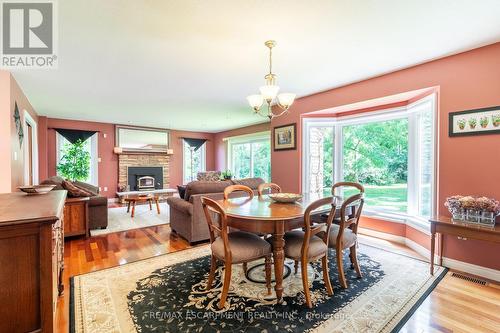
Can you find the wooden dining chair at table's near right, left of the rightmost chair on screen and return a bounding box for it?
[271,197,337,308]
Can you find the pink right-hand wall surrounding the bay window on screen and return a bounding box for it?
[272,43,500,269]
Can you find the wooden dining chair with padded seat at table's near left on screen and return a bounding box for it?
[201,197,272,309]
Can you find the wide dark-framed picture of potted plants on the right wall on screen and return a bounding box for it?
[448,106,500,137]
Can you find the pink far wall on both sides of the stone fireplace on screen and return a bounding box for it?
[38,117,215,198]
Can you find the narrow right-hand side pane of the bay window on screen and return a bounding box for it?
[418,112,434,217]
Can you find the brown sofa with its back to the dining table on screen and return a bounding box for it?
[167,178,264,244]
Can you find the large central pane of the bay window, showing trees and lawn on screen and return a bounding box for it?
[342,119,408,212]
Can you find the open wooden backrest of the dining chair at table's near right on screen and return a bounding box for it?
[302,197,337,254]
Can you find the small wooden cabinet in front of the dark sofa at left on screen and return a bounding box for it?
[64,198,89,237]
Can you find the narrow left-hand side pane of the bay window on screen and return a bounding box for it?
[309,127,333,193]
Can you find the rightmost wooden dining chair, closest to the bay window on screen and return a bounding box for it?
[329,186,364,288]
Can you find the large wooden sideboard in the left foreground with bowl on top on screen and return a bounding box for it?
[0,191,66,333]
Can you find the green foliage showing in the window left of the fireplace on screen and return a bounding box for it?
[57,140,90,181]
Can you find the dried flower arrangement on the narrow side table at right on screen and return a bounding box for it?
[444,195,500,224]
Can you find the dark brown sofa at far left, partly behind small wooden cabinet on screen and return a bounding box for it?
[41,176,108,229]
